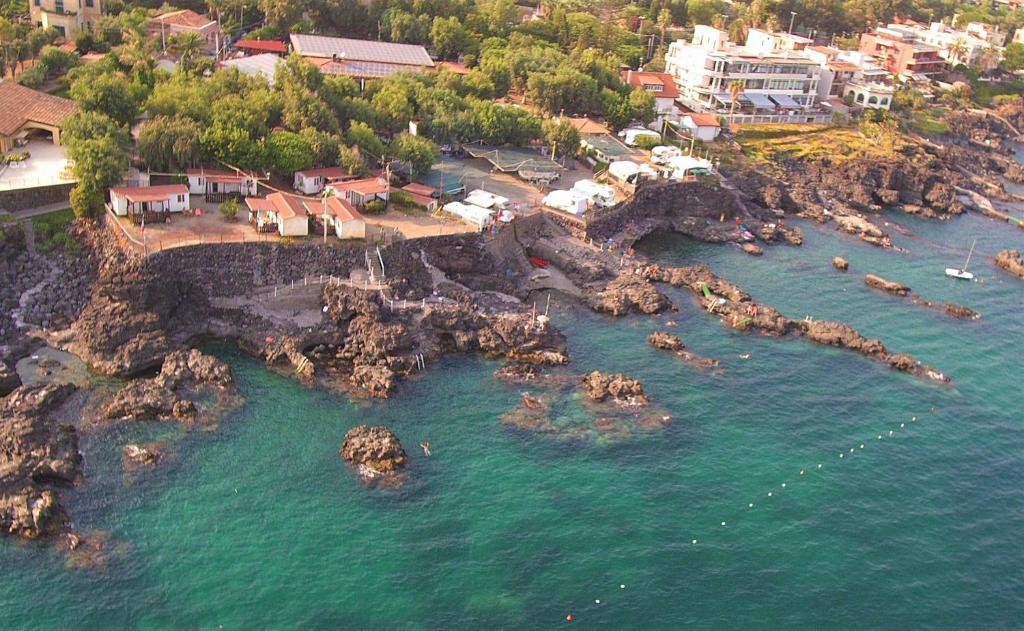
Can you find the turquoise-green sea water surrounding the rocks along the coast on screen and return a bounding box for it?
[0,205,1024,629]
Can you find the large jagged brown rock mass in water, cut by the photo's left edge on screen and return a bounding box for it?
[0,385,82,539]
